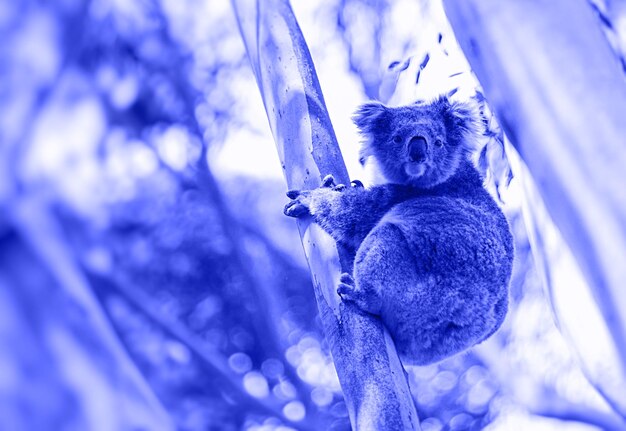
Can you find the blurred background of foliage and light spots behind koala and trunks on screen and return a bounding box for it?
[0,0,626,431]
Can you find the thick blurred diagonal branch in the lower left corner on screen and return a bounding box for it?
[10,196,173,430]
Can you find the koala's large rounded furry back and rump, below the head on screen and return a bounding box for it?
[356,181,513,364]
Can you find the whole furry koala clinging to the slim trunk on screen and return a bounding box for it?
[284,96,514,365]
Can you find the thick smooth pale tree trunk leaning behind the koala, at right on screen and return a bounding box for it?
[444,0,626,416]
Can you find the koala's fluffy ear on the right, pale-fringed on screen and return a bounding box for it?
[442,97,484,147]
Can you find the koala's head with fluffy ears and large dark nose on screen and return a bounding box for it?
[353,96,481,188]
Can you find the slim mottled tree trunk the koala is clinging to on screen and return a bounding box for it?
[232,0,419,430]
